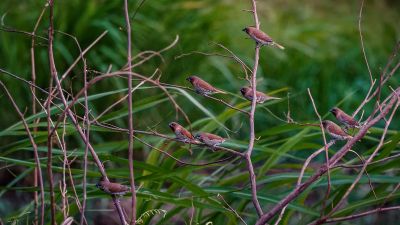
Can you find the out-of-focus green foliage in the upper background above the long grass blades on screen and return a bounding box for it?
[0,0,400,126]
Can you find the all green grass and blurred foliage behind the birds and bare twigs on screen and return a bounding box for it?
[0,0,400,224]
